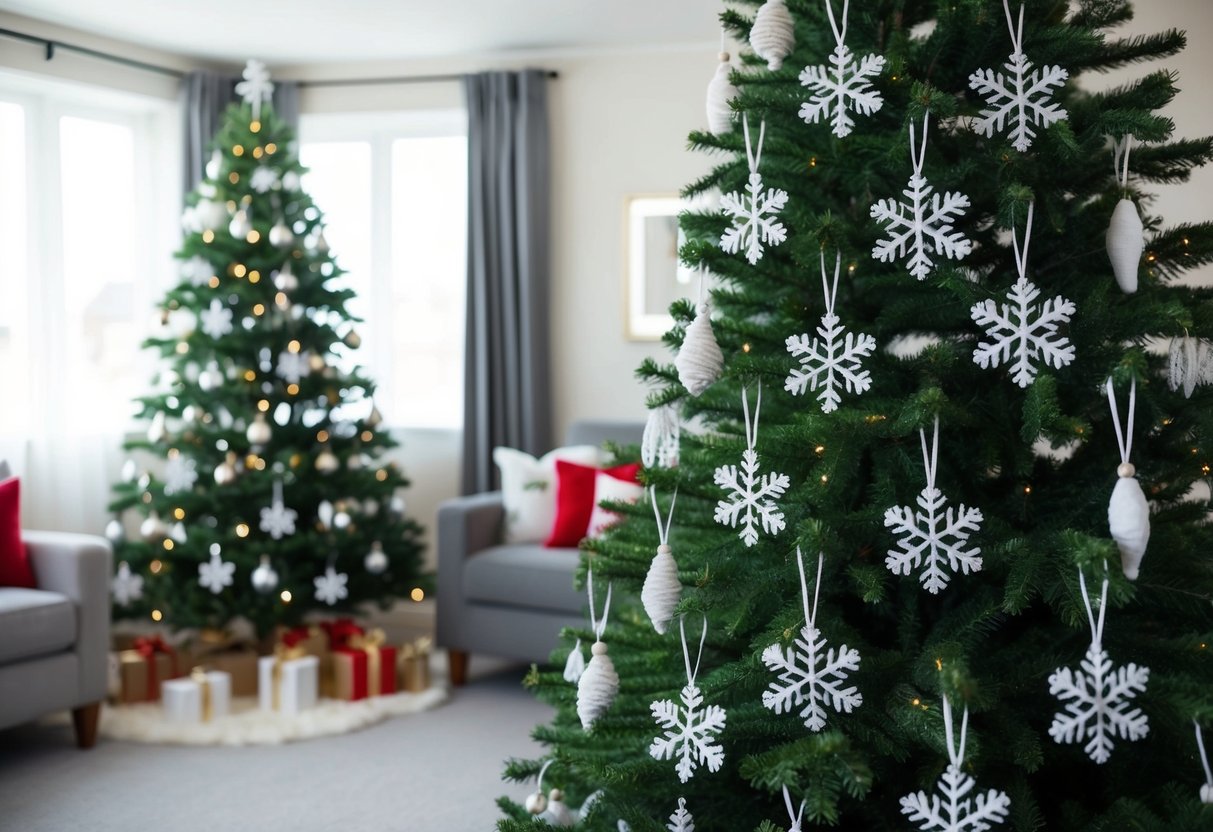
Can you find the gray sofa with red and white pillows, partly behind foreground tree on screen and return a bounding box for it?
[437,421,644,685]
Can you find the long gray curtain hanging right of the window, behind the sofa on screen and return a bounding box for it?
[462,69,552,494]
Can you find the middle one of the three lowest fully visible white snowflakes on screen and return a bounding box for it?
[762,546,864,731]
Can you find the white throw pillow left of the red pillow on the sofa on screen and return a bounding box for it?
[492,445,602,543]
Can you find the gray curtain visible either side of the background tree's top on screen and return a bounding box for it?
[181,69,300,194]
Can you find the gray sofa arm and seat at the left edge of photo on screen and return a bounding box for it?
[0,531,112,748]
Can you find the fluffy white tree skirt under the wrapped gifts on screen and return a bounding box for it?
[93,686,448,746]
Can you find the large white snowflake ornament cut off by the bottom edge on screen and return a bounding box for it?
[901,696,1010,832]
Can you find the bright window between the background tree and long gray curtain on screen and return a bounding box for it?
[300,112,467,428]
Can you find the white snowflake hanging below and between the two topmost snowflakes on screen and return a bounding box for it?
[870,114,973,280]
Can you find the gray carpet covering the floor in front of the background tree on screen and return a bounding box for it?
[0,657,549,832]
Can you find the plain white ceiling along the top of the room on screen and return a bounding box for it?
[0,0,721,65]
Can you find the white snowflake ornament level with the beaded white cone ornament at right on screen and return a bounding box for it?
[884,416,983,595]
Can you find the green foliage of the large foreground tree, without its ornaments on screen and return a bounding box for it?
[500,0,1213,832]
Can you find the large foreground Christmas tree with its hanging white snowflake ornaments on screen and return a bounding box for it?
[500,0,1213,832]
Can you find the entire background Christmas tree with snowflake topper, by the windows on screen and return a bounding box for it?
[110,62,421,633]
